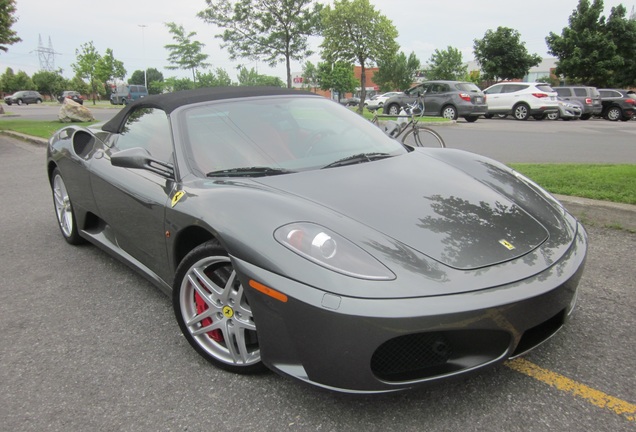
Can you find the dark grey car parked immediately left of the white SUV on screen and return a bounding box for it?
[384,81,488,122]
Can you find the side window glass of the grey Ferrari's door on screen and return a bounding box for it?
[115,108,172,162]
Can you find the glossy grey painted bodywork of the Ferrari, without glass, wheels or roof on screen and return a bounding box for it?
[47,93,586,392]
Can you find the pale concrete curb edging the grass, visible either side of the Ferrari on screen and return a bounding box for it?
[0,131,636,232]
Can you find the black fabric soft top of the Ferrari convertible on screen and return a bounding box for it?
[102,87,317,133]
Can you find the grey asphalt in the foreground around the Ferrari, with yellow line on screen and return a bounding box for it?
[0,136,636,431]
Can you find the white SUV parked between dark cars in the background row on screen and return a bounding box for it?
[484,82,559,120]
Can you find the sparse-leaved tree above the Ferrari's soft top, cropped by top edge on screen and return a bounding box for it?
[198,0,322,88]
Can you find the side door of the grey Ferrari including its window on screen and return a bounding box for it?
[90,108,174,281]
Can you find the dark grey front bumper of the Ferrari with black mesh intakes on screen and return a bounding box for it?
[233,225,587,393]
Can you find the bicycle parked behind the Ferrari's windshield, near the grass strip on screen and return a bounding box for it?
[371,101,446,148]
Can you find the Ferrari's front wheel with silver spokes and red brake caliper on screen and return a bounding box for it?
[172,240,265,373]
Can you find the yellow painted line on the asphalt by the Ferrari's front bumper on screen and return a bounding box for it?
[504,358,636,421]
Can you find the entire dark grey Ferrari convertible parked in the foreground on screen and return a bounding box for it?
[46,87,587,393]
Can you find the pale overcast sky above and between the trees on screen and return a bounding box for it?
[0,0,636,81]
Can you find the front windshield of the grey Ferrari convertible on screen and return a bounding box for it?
[178,96,408,177]
